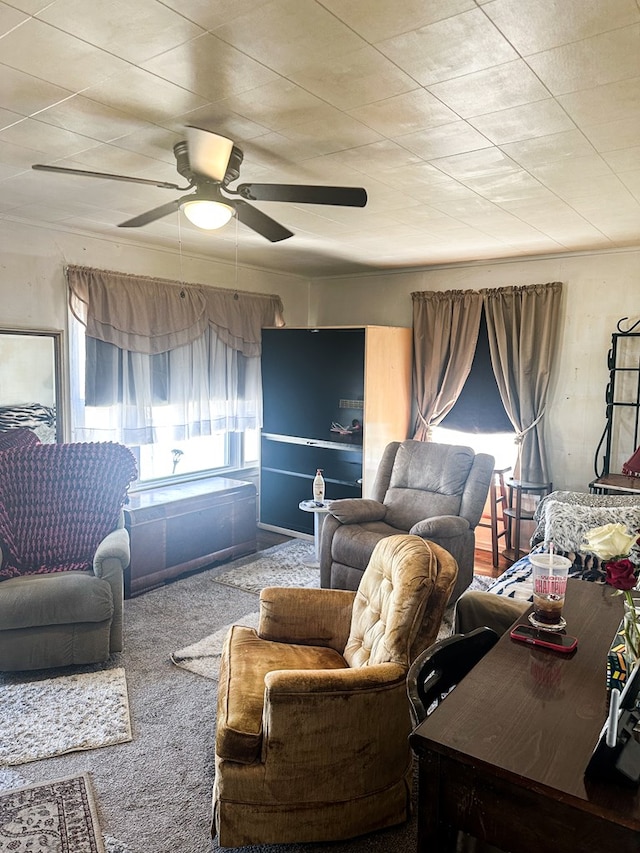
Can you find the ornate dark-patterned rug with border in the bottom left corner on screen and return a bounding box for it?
[0,773,105,853]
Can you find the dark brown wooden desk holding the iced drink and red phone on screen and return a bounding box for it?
[411,580,640,853]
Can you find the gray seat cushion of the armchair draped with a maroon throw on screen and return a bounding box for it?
[0,572,114,630]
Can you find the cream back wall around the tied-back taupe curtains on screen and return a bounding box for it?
[309,250,640,491]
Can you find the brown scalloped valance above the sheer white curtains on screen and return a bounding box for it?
[66,266,284,356]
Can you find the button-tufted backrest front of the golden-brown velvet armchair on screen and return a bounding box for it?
[343,535,438,667]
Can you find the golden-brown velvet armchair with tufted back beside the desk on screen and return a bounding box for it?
[213,535,457,847]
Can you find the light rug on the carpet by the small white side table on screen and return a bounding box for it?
[216,539,320,593]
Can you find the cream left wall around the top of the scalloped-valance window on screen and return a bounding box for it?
[0,221,308,432]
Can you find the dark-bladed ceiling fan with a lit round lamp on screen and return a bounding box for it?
[32,127,367,243]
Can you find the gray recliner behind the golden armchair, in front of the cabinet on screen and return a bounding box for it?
[320,440,494,604]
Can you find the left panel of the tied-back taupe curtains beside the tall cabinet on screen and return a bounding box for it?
[411,290,482,441]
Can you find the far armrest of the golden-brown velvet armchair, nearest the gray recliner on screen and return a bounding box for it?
[258,587,355,654]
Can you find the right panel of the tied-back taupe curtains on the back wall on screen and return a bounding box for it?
[481,281,562,483]
